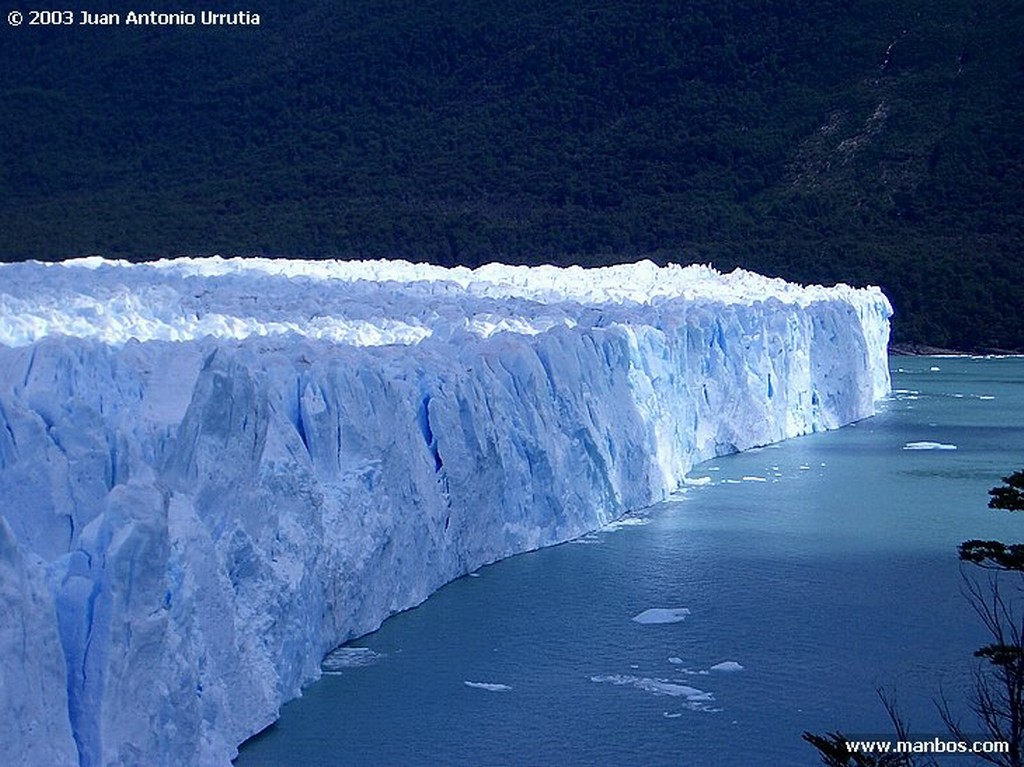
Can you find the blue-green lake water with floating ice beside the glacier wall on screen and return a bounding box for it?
[237,357,1024,767]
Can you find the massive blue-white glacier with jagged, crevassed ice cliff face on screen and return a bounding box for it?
[0,257,892,767]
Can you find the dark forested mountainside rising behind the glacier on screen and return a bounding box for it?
[0,0,1024,350]
